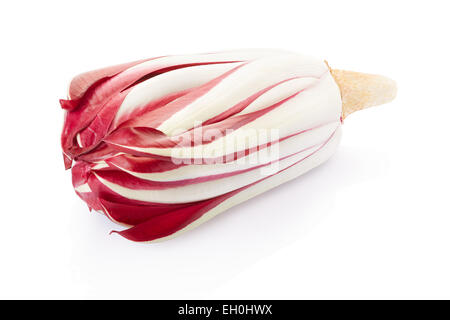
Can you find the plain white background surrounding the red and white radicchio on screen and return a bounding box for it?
[0,0,450,299]
